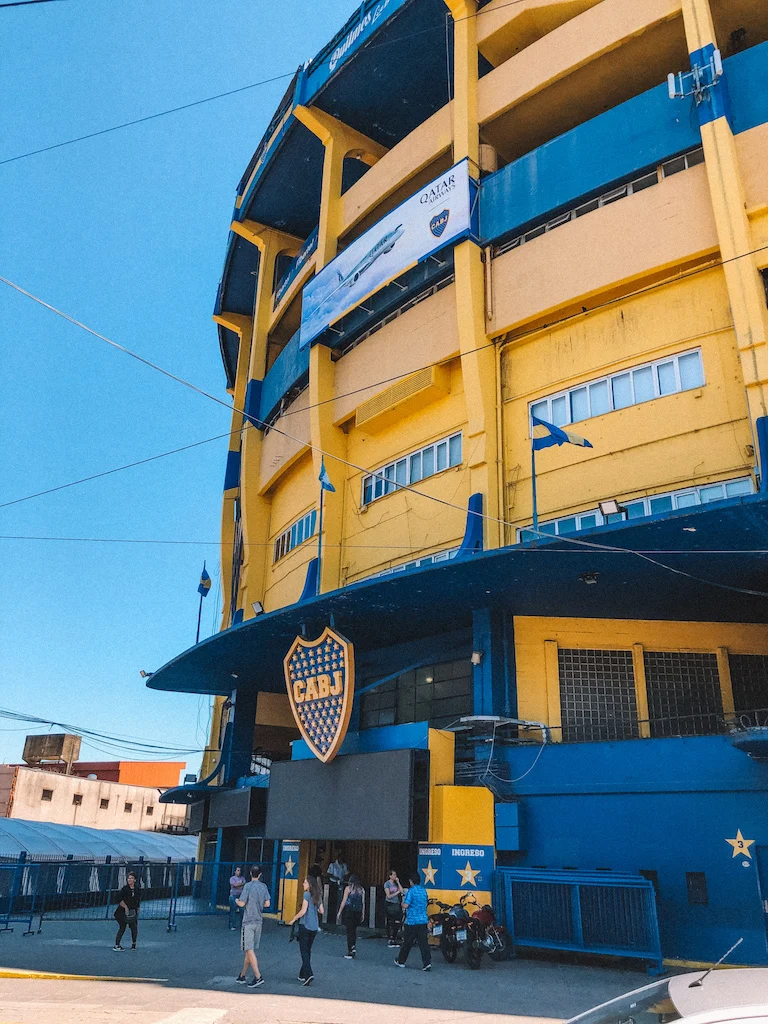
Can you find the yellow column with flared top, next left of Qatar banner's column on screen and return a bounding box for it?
[231,220,301,618]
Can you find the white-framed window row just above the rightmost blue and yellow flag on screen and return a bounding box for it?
[528,349,705,427]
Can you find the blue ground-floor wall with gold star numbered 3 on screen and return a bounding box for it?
[505,736,768,965]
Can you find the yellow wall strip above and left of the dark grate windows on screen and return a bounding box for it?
[514,615,768,740]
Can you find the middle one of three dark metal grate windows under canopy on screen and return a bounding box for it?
[644,650,723,736]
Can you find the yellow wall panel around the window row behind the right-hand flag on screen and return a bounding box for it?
[502,264,755,540]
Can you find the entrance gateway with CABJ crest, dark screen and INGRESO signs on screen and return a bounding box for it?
[274,626,495,912]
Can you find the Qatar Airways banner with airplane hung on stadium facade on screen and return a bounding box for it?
[299,160,476,348]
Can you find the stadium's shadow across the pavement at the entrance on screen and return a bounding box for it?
[0,918,671,1020]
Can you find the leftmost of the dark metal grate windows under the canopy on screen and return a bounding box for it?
[557,647,638,742]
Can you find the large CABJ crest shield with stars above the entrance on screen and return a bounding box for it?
[283,626,354,763]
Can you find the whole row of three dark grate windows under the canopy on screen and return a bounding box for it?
[557,648,768,742]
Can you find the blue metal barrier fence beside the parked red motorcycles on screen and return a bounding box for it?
[494,867,662,973]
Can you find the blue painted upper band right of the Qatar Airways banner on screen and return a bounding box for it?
[480,43,768,244]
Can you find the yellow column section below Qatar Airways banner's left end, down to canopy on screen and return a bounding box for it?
[309,345,347,594]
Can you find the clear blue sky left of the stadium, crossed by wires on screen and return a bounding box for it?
[0,0,353,768]
